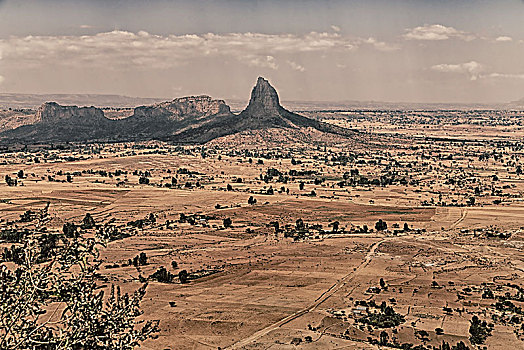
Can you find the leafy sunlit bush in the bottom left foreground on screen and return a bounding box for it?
[0,234,159,350]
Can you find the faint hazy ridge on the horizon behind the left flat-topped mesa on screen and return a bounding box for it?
[0,93,164,109]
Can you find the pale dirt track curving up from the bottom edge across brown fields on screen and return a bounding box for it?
[225,237,392,349]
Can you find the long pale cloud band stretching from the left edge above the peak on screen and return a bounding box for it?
[0,30,394,71]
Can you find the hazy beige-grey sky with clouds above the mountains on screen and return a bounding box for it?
[0,0,524,102]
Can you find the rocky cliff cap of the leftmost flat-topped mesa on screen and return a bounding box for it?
[36,102,105,123]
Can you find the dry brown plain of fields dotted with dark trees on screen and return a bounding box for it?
[0,111,524,349]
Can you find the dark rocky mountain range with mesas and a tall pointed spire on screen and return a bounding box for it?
[0,78,354,143]
